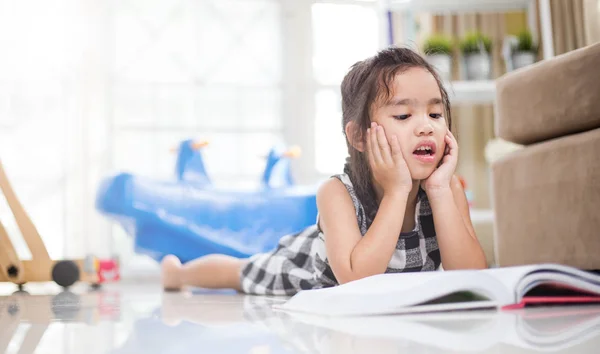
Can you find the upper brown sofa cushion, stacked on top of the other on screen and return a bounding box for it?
[496,43,600,144]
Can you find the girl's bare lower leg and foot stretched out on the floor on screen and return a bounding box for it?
[161,254,245,291]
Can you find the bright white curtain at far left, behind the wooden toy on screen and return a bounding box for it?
[0,0,110,258]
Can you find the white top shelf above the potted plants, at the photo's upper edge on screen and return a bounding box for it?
[389,0,532,13]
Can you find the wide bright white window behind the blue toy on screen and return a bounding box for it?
[110,0,283,276]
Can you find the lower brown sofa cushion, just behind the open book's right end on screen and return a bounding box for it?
[492,129,600,269]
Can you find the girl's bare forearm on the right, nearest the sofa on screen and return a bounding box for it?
[428,176,487,270]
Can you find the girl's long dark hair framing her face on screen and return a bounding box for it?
[341,47,452,224]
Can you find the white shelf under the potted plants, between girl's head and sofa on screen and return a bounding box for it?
[444,80,496,105]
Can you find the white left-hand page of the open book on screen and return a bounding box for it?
[276,271,508,316]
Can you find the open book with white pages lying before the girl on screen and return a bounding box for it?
[274,264,600,316]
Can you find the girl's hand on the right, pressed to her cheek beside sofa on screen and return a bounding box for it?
[421,130,458,197]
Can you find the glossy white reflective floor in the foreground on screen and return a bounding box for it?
[0,284,600,354]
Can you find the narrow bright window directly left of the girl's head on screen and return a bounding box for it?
[312,2,379,175]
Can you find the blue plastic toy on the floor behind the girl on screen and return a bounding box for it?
[96,141,317,262]
